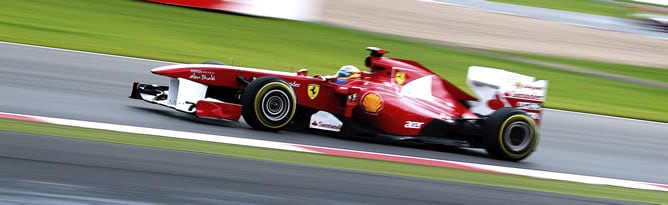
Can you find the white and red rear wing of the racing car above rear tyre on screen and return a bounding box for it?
[466,66,547,123]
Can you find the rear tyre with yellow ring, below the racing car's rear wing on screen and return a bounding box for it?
[483,107,538,161]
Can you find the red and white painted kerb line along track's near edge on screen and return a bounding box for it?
[0,112,668,192]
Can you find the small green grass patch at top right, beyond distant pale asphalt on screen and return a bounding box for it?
[490,0,631,17]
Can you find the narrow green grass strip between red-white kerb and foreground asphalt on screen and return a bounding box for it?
[0,119,668,204]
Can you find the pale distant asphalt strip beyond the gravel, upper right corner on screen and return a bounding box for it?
[432,0,668,40]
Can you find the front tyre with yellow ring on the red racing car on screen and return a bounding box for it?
[241,76,297,131]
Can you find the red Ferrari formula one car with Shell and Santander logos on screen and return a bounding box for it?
[130,47,547,161]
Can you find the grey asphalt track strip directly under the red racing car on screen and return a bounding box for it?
[0,44,668,199]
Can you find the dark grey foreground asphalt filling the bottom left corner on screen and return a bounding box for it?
[0,132,631,205]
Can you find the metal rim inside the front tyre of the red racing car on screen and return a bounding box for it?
[261,90,290,122]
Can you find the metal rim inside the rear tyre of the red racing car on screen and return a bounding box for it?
[503,121,532,152]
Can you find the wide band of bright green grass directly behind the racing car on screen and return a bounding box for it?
[0,0,668,122]
